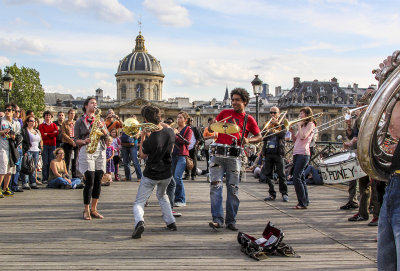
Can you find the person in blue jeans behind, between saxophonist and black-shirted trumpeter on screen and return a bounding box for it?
[121,132,142,182]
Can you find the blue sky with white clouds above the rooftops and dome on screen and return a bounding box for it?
[0,0,400,101]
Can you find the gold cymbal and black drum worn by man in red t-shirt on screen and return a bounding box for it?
[209,121,242,158]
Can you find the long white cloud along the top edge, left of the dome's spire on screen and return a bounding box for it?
[4,0,133,23]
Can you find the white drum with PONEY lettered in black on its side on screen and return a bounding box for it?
[318,152,367,184]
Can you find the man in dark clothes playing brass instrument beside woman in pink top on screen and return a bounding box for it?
[262,106,289,202]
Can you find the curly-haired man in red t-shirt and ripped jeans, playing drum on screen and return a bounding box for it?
[208,88,262,231]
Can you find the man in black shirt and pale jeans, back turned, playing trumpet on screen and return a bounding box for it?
[132,105,177,239]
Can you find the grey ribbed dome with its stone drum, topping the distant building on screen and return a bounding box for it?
[115,32,165,102]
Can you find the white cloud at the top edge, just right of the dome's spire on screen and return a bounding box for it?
[143,0,192,27]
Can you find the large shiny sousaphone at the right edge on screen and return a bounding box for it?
[357,51,400,181]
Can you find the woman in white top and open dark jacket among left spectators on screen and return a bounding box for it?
[21,115,43,190]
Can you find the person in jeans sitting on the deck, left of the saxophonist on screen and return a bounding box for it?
[47,148,83,189]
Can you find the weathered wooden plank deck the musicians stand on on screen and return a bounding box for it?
[0,163,377,270]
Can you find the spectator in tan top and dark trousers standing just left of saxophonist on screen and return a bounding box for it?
[61,109,78,178]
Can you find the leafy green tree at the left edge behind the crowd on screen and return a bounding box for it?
[0,63,45,115]
